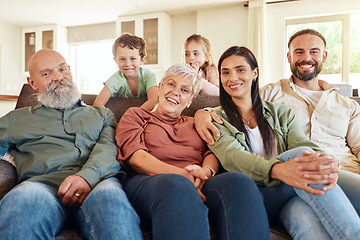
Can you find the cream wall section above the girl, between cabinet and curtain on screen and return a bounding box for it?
[171,4,247,67]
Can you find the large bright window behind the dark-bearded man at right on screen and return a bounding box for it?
[286,13,360,88]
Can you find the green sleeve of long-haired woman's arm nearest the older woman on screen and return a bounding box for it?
[209,111,281,186]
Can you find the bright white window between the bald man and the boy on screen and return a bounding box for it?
[70,39,118,94]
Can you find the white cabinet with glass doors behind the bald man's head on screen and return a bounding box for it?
[21,25,69,75]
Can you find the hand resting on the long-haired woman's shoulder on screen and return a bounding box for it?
[194,109,223,146]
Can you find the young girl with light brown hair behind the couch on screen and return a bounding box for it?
[183,34,219,96]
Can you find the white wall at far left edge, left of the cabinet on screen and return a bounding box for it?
[0,20,26,95]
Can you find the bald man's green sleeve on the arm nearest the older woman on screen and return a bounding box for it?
[76,108,120,187]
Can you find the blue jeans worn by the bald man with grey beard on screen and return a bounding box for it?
[0,177,142,240]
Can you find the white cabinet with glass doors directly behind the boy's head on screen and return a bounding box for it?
[116,12,171,70]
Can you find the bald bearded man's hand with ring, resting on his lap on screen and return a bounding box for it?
[58,175,91,207]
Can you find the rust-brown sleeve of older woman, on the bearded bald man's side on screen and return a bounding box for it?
[115,108,148,162]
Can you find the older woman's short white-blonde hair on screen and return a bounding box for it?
[159,63,201,98]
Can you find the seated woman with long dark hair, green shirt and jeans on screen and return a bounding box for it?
[209,47,360,239]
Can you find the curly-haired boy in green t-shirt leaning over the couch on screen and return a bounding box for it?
[93,33,158,111]
